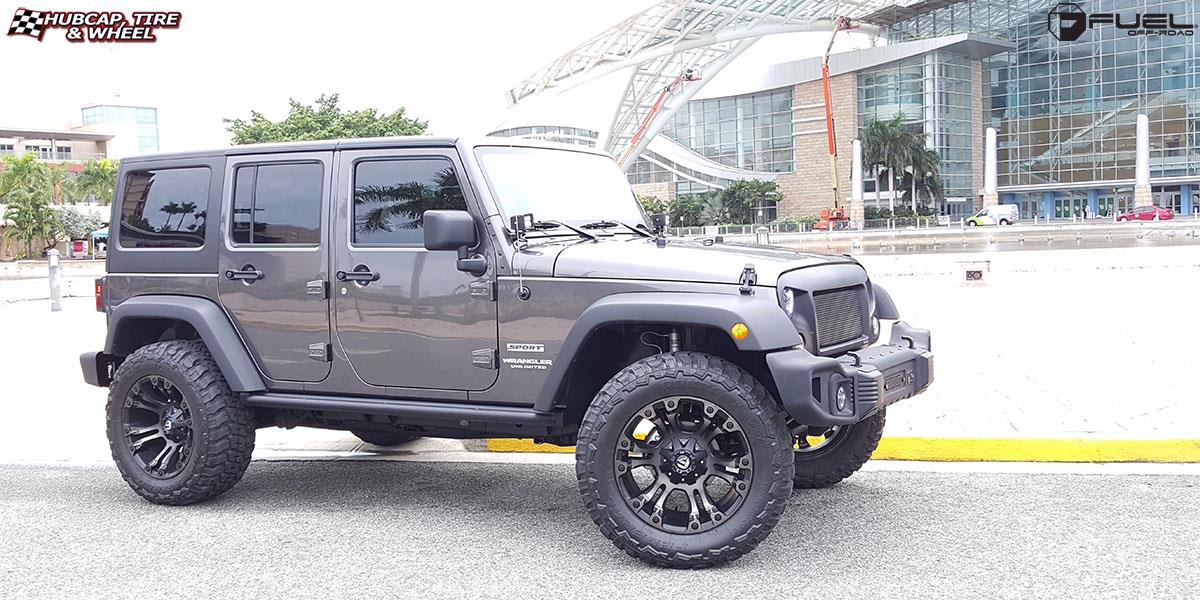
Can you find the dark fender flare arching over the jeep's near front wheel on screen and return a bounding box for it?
[534,292,803,412]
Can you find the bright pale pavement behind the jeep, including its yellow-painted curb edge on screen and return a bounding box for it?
[0,247,1200,462]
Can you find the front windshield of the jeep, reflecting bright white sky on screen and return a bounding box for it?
[475,146,646,233]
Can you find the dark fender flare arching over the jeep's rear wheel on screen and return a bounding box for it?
[104,295,266,391]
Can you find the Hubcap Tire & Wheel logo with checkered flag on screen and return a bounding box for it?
[8,8,182,43]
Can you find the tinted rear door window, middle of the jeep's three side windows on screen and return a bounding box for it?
[229,162,325,245]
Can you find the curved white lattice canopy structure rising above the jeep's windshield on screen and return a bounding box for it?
[509,0,911,167]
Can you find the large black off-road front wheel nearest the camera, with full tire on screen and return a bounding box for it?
[575,352,793,569]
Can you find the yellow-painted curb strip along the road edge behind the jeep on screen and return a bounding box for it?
[487,437,1200,462]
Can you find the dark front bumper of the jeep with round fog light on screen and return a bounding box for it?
[767,320,934,427]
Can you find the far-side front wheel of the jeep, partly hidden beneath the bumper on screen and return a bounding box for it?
[793,410,886,490]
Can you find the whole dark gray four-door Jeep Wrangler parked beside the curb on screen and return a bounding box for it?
[80,138,932,568]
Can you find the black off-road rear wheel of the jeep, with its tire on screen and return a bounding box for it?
[106,340,254,504]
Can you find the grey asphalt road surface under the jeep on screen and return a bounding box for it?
[0,461,1200,599]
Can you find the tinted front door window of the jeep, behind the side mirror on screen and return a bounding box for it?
[353,158,467,246]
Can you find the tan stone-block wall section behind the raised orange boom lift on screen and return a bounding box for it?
[776,73,858,218]
